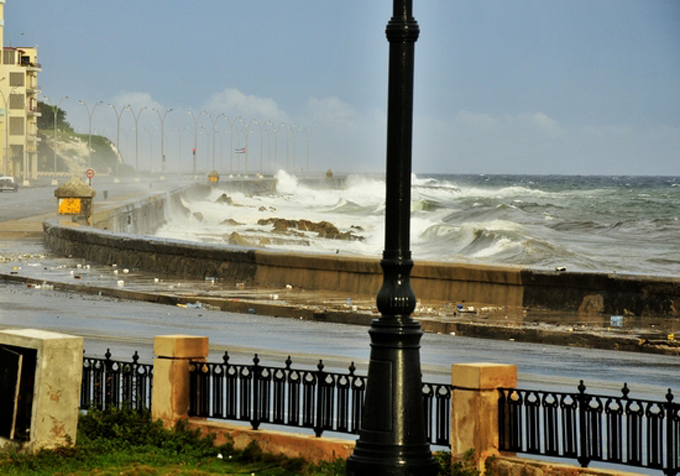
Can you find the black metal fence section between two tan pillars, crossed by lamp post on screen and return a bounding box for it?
[189,352,453,446]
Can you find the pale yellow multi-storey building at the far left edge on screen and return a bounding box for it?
[0,0,41,185]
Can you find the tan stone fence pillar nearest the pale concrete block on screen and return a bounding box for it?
[151,335,208,427]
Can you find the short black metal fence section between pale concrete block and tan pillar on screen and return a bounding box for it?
[80,349,153,410]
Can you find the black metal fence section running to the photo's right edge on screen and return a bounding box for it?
[498,381,680,476]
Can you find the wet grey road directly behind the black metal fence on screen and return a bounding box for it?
[0,282,680,399]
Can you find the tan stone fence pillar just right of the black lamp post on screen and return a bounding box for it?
[451,363,517,472]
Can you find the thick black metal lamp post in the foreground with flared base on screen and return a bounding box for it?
[347,0,438,476]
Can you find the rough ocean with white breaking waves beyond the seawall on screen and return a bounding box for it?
[157,171,680,277]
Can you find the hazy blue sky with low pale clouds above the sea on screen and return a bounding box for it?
[4,0,680,176]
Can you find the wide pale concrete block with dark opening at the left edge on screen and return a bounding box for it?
[0,329,83,453]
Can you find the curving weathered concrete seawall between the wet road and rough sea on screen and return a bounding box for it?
[43,180,680,316]
